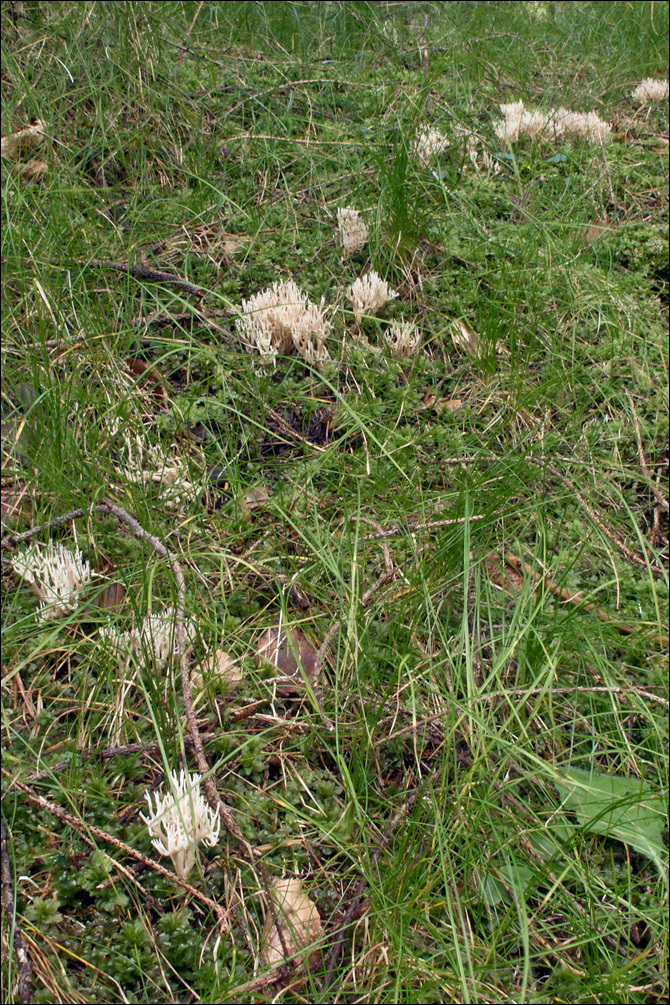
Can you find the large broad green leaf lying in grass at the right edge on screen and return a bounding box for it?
[556,768,667,872]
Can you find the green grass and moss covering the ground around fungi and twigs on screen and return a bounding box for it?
[2,2,668,1003]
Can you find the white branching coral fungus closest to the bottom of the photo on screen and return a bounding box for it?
[140,768,221,879]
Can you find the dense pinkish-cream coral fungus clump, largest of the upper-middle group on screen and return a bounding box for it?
[236,280,330,364]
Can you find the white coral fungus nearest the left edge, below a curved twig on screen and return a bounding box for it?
[12,541,93,621]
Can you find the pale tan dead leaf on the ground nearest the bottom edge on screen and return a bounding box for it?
[261,876,322,972]
